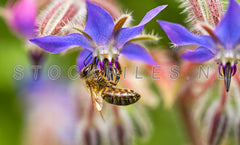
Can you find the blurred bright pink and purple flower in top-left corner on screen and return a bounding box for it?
[5,0,37,38]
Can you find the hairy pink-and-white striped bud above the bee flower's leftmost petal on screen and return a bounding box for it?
[37,0,86,36]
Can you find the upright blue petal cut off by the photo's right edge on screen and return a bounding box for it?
[215,0,240,49]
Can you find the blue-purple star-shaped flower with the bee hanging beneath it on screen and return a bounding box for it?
[30,1,166,70]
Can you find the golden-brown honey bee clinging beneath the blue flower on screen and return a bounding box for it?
[80,59,140,112]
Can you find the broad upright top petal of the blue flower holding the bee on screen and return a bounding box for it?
[84,1,114,46]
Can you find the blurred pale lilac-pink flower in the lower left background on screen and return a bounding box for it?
[18,79,79,145]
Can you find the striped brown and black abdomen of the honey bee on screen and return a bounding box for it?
[102,87,140,105]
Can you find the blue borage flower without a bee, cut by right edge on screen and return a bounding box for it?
[158,0,240,91]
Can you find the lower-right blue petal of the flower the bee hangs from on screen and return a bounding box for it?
[120,43,157,65]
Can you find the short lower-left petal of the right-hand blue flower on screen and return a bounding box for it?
[181,47,214,62]
